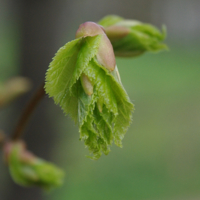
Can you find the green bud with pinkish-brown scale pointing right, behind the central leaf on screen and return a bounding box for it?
[99,15,167,57]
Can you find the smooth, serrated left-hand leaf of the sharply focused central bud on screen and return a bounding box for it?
[45,36,101,122]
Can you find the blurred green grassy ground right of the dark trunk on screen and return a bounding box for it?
[46,45,200,200]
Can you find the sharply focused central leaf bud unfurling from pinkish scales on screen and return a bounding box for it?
[45,22,134,159]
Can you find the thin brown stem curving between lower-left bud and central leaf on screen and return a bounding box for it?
[11,83,45,140]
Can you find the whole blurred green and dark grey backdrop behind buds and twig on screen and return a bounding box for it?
[0,0,200,200]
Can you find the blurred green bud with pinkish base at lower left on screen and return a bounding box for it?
[4,141,64,190]
